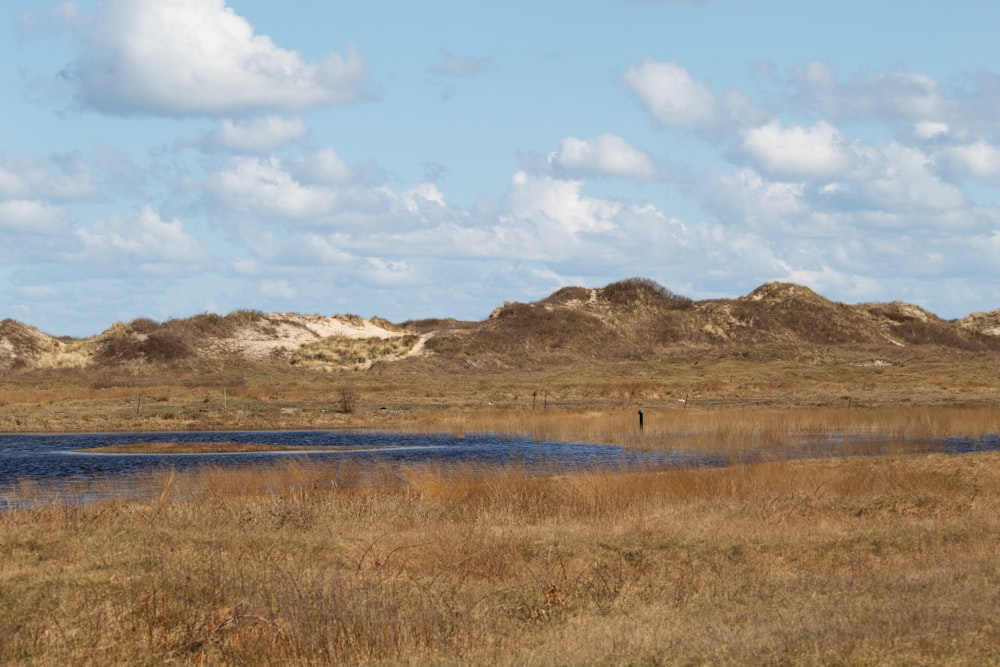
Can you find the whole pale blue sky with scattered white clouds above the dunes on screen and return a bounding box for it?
[0,0,1000,337]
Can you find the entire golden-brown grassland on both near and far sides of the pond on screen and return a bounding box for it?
[0,351,1000,665]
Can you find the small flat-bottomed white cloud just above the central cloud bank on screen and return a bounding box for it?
[549,134,656,181]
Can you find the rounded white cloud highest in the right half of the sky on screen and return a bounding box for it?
[623,58,717,128]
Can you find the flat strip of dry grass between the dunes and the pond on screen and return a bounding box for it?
[0,336,1000,440]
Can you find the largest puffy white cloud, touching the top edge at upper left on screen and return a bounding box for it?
[67,0,366,115]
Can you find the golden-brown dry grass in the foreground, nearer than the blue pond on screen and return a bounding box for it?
[0,453,1000,665]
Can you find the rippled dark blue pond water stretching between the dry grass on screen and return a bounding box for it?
[0,431,1000,510]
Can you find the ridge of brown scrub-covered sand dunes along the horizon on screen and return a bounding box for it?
[0,278,1000,370]
